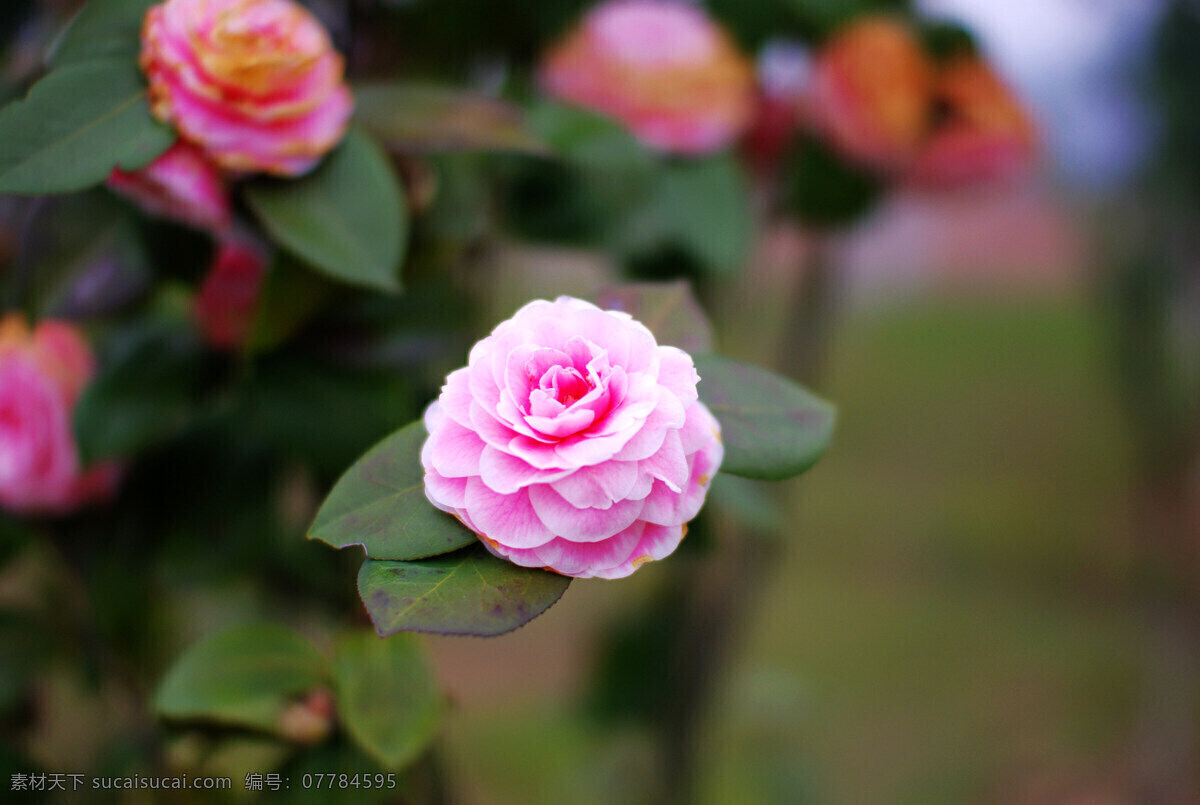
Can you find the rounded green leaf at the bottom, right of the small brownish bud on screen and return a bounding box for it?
[334,632,444,769]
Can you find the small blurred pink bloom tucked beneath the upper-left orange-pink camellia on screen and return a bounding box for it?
[108,140,233,233]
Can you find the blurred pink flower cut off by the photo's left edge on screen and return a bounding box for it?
[0,314,119,515]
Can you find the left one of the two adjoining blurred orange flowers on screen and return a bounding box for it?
[808,16,934,170]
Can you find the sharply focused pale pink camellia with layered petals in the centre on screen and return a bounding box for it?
[421,296,725,578]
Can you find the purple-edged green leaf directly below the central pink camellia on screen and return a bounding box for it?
[359,545,571,637]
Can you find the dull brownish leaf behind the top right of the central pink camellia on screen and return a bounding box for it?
[596,280,713,355]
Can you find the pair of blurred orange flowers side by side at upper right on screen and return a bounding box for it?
[806,17,1036,187]
